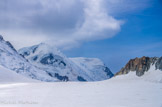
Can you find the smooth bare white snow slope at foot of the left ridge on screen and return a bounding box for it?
[0,66,36,83]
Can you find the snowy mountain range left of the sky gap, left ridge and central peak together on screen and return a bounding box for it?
[0,36,113,81]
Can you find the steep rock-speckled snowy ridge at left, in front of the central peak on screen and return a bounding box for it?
[0,36,58,81]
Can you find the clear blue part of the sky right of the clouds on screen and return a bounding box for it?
[65,1,162,73]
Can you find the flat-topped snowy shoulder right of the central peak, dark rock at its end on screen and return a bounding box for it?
[70,57,113,81]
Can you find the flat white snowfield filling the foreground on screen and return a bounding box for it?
[0,71,162,107]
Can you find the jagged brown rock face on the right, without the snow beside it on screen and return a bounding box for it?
[115,56,160,76]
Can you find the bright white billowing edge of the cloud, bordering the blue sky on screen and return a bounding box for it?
[43,0,122,49]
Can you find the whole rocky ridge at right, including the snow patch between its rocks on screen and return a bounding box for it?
[115,56,162,79]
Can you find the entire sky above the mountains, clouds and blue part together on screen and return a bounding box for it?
[0,0,162,73]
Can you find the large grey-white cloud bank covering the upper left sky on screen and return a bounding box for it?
[0,0,151,49]
